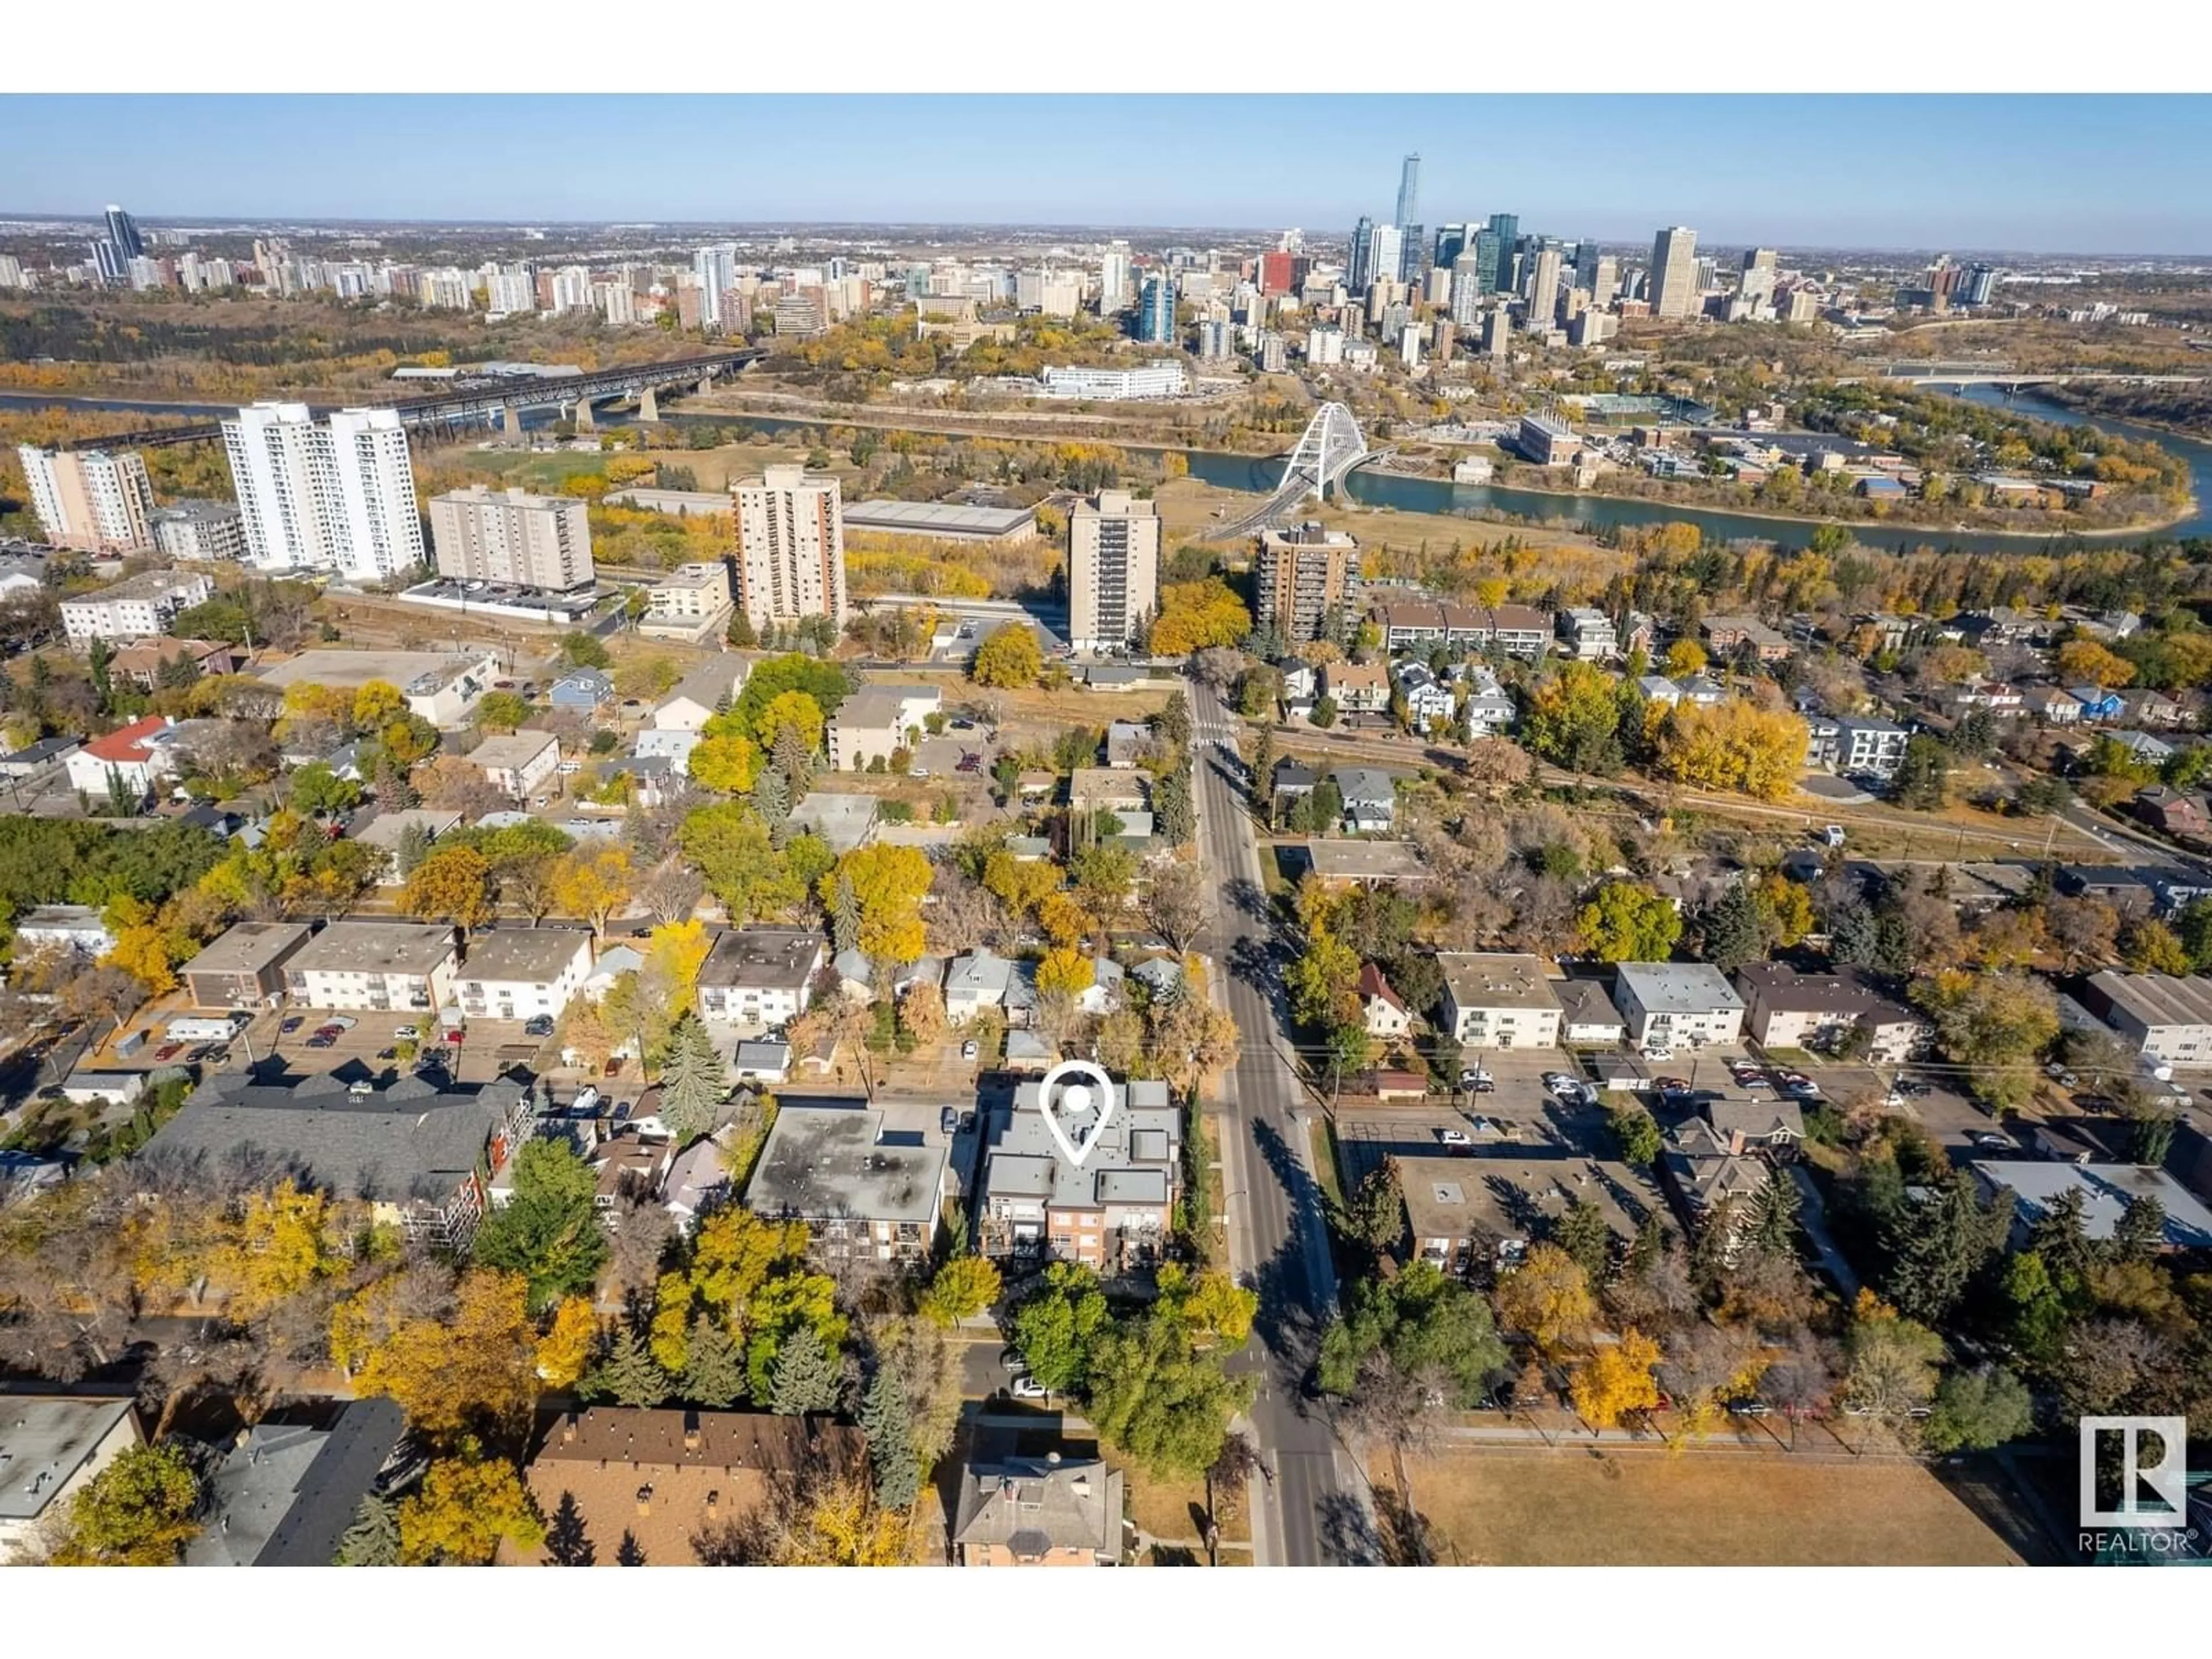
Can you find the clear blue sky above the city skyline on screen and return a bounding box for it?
[0,93,2212,255]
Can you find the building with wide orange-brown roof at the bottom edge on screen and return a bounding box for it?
[498,1404,867,1566]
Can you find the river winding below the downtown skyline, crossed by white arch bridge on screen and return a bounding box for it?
[0,385,2212,553]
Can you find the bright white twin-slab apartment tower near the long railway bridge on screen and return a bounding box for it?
[224,403,422,582]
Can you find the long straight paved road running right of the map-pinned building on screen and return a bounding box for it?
[1190,684,1376,1566]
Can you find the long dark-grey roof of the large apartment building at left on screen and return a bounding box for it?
[137,1073,522,1203]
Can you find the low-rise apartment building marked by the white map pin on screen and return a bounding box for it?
[975,1080,1183,1274]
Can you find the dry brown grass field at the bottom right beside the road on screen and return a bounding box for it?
[1374,1451,2020,1566]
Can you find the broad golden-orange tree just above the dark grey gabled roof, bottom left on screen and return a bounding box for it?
[343,1270,537,1435]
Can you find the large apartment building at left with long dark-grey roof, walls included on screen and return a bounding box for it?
[144,1071,531,1250]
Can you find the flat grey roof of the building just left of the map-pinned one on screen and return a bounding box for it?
[745,1099,947,1225]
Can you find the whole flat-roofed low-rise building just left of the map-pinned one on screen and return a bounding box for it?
[745,1097,951,1267]
